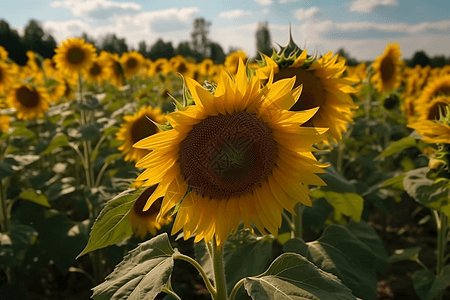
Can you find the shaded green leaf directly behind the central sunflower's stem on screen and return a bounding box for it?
[195,229,272,292]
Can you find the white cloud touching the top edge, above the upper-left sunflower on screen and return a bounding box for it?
[50,0,142,19]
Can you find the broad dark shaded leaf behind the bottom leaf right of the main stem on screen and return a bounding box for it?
[284,225,379,299]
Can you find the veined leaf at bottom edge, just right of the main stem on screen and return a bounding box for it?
[244,253,356,300]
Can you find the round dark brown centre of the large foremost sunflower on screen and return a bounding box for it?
[179,111,276,199]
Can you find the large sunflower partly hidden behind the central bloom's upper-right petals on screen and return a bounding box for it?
[256,45,357,142]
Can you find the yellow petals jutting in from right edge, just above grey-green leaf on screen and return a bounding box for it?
[408,120,450,144]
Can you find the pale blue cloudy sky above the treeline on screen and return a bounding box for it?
[0,0,450,60]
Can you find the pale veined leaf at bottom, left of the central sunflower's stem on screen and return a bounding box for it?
[92,233,175,300]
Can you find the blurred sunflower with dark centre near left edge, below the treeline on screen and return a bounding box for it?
[6,83,50,120]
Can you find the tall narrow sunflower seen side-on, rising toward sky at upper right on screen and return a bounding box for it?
[372,44,403,93]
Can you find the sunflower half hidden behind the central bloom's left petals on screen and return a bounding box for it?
[117,106,166,162]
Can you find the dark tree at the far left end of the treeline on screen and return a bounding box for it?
[0,20,28,65]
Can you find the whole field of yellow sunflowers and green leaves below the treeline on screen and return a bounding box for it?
[0,38,450,300]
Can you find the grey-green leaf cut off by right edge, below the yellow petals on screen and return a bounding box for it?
[403,167,450,215]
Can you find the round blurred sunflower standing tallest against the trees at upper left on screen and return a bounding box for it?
[53,38,97,76]
